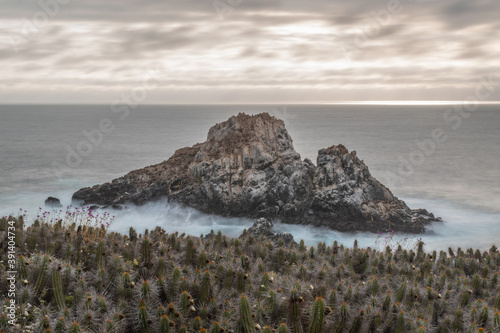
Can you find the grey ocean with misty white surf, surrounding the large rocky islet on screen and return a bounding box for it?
[0,104,500,249]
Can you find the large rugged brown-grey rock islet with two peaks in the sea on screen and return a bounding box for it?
[73,113,440,232]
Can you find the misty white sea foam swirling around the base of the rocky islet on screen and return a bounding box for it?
[0,191,500,250]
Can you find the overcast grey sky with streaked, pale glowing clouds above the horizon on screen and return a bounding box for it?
[0,0,500,104]
